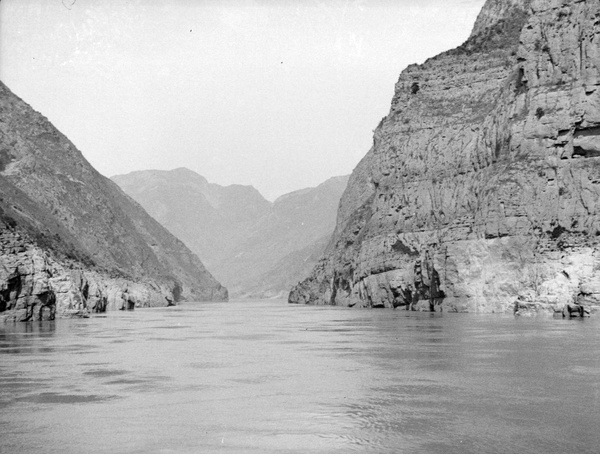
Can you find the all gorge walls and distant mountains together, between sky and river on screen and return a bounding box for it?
[0,0,600,320]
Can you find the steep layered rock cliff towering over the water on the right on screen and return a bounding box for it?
[289,0,600,312]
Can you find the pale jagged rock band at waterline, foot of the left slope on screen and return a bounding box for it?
[0,229,183,322]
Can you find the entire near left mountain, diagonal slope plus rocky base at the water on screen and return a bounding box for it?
[0,82,227,320]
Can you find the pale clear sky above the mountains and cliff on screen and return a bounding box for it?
[0,0,484,200]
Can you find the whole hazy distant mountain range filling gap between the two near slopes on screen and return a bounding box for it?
[112,168,348,298]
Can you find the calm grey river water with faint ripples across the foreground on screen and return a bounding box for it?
[0,301,600,453]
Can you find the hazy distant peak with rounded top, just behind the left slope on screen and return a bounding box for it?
[112,168,271,276]
